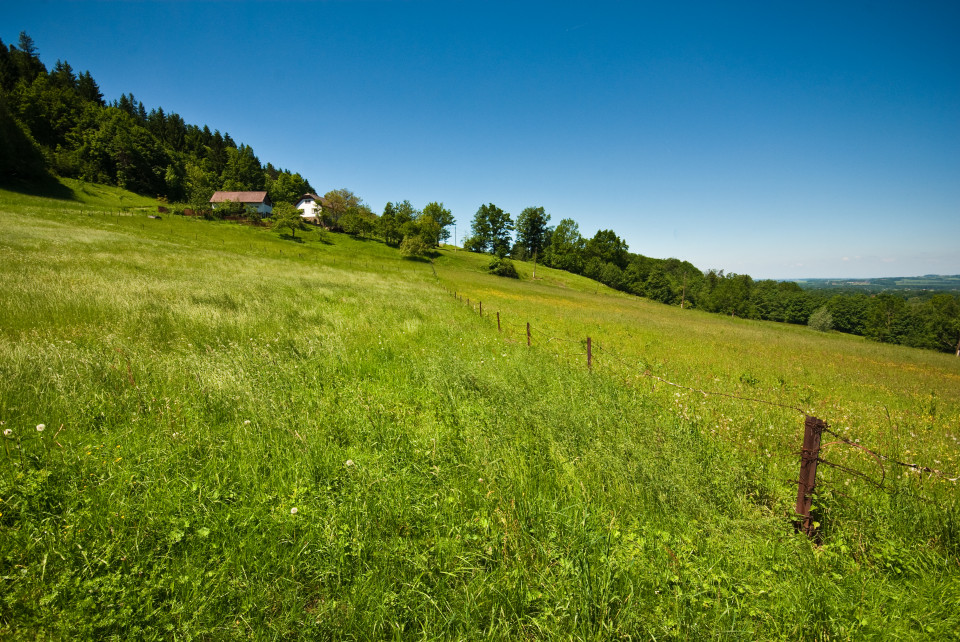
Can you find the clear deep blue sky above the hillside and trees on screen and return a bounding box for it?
[0,0,960,278]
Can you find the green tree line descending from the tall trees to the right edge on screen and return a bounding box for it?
[463,203,960,356]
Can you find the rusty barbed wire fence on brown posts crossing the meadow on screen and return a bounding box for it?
[445,287,960,538]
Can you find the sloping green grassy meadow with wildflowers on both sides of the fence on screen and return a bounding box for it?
[0,182,960,640]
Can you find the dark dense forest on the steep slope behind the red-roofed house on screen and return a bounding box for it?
[0,32,313,208]
